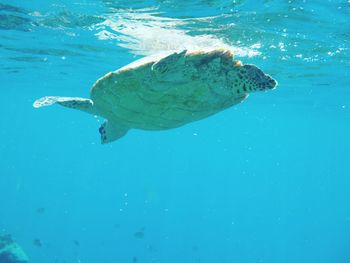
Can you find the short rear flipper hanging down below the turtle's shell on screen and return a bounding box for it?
[98,121,129,144]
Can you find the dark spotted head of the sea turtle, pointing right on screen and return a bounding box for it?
[237,65,277,92]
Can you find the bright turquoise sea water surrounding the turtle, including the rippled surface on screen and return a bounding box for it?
[0,0,350,263]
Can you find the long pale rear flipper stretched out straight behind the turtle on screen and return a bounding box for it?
[33,96,97,114]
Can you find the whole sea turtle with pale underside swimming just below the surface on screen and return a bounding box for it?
[33,49,277,143]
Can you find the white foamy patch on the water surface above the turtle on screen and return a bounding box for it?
[95,10,260,57]
